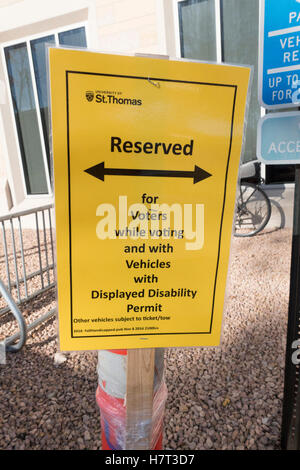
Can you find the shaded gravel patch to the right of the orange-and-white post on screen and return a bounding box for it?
[165,316,284,450]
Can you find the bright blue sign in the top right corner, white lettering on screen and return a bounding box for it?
[259,0,300,108]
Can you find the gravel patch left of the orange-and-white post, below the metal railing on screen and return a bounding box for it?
[0,320,101,450]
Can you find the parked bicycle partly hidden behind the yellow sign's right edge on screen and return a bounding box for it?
[234,160,272,237]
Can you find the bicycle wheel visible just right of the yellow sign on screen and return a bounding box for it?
[234,183,271,237]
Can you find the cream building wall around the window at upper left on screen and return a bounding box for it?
[0,0,175,215]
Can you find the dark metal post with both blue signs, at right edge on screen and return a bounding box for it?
[257,0,300,450]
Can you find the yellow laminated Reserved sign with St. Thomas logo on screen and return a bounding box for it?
[49,48,250,350]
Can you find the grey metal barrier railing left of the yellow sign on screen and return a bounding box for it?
[0,204,56,360]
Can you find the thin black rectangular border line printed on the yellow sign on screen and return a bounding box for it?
[66,70,238,339]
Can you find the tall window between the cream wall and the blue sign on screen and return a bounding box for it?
[178,0,260,161]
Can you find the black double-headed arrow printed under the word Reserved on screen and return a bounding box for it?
[84,162,212,184]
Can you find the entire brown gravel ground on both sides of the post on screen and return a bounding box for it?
[0,229,291,450]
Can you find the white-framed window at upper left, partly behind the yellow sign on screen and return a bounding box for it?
[4,27,87,195]
